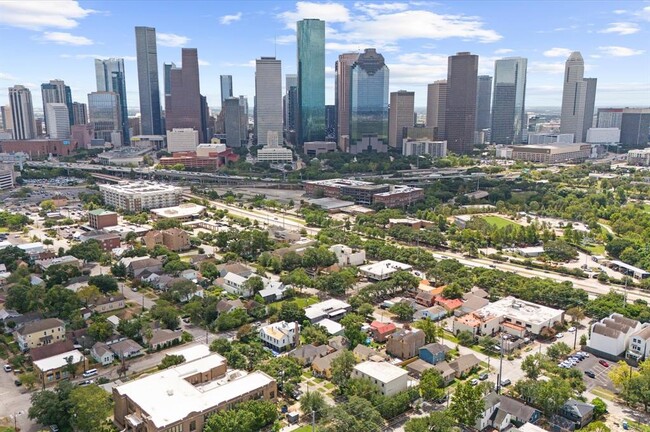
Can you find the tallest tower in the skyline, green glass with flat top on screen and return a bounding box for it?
[297,19,325,145]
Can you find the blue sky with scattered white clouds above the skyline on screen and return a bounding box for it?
[0,0,650,109]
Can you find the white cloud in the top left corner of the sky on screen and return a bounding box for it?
[0,0,95,30]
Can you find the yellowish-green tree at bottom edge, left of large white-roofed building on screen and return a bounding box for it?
[70,385,112,432]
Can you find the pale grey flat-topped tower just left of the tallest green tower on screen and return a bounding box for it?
[255,57,283,146]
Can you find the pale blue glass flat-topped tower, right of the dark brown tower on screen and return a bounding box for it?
[490,57,528,144]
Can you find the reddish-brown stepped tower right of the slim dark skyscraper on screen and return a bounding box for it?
[165,48,207,142]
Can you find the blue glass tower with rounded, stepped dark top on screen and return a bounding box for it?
[350,48,388,145]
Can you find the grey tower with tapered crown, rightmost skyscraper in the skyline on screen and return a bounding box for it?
[560,51,596,142]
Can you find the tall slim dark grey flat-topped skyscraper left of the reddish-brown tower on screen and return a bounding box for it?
[135,27,163,135]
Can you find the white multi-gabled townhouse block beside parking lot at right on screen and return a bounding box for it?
[587,313,641,357]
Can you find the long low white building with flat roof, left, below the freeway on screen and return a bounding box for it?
[99,181,183,212]
